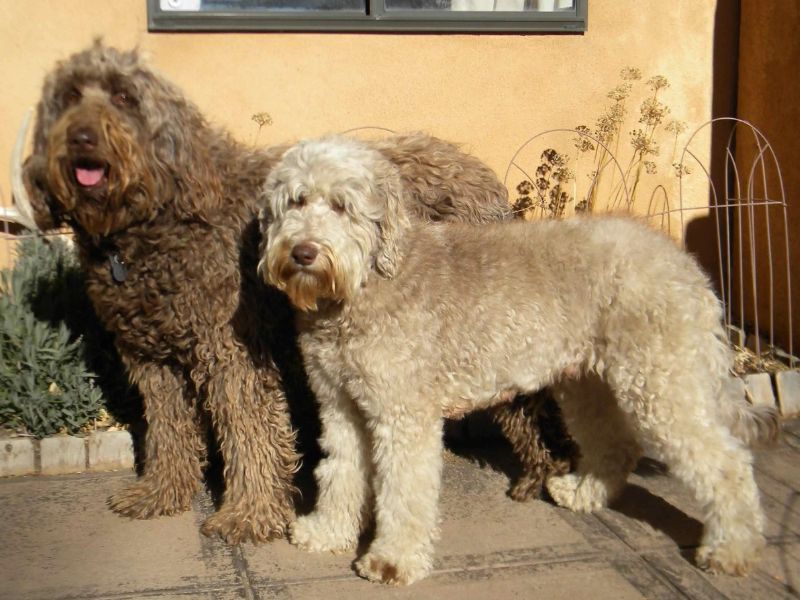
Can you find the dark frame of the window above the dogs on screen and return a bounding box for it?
[147,0,588,34]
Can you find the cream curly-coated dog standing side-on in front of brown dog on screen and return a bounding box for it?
[259,138,774,584]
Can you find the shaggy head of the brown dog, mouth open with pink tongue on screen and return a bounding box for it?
[23,41,220,236]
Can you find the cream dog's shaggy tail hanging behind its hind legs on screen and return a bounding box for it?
[722,377,781,446]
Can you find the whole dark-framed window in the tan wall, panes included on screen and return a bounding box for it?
[147,0,588,33]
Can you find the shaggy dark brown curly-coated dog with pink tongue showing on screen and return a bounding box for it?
[24,41,568,543]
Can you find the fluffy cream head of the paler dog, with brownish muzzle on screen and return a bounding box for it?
[258,137,409,311]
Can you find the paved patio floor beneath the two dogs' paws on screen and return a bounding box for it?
[0,420,800,600]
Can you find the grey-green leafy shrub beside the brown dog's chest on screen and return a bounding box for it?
[0,237,141,437]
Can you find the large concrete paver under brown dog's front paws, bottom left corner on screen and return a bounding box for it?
[0,474,244,600]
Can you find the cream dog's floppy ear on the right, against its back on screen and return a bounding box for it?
[375,160,410,279]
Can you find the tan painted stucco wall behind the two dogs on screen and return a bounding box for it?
[0,0,716,268]
